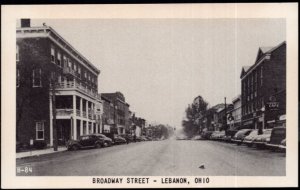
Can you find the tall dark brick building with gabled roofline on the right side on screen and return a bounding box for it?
[240,42,286,129]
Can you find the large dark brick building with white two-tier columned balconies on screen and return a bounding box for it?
[16,19,101,146]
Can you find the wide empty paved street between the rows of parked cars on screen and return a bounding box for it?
[17,139,286,176]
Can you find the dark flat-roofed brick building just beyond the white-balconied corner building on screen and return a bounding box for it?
[101,92,129,134]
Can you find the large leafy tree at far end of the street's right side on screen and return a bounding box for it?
[182,96,208,137]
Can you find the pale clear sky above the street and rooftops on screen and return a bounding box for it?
[21,19,286,128]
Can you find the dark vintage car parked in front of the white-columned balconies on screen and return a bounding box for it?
[66,135,104,150]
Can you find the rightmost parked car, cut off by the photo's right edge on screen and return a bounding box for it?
[266,127,286,150]
